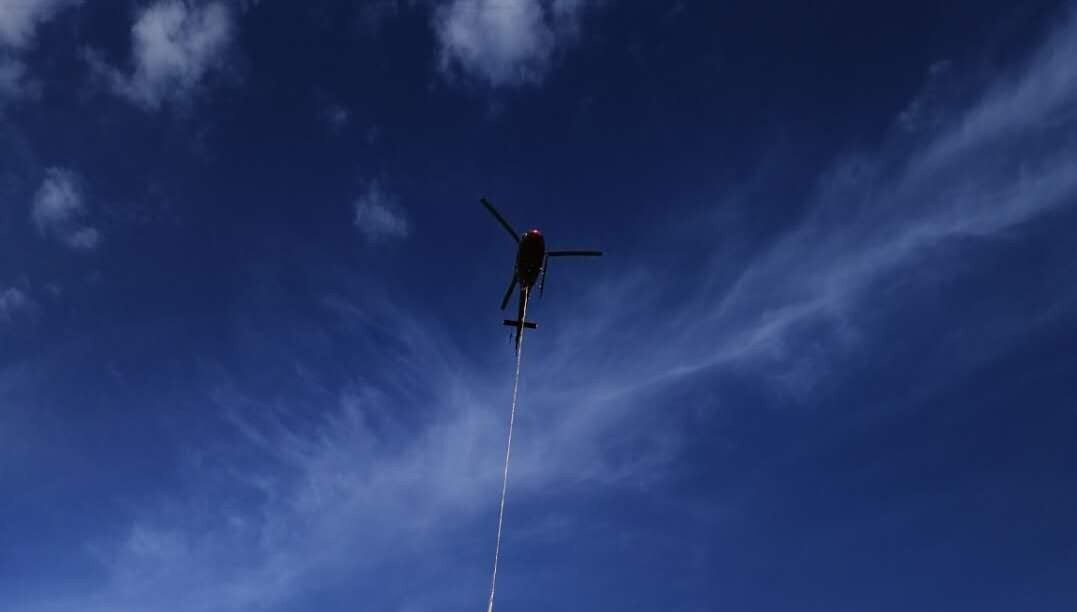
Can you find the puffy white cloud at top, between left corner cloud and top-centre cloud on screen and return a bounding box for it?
[89,0,235,110]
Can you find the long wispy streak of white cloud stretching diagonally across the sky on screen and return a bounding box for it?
[12,9,1077,612]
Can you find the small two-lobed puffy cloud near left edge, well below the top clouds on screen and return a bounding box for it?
[30,168,101,251]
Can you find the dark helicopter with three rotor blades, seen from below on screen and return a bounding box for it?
[479,197,602,350]
